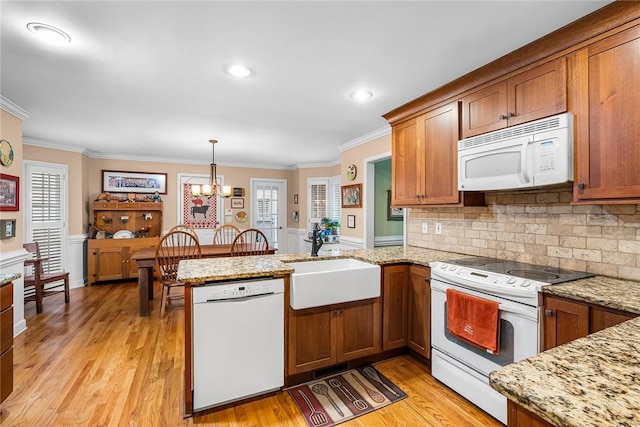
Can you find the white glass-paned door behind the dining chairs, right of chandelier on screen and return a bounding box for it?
[251,179,287,253]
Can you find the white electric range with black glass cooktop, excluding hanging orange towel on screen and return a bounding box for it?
[431,257,592,424]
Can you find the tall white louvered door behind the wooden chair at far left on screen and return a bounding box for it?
[24,162,68,272]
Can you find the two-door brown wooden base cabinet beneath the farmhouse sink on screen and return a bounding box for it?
[287,298,381,375]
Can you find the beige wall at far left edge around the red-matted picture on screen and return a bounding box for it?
[0,110,24,252]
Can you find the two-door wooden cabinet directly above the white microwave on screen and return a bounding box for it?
[462,58,567,138]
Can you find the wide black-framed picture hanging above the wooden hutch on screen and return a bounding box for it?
[102,170,167,194]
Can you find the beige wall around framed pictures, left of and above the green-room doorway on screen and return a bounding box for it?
[340,134,391,239]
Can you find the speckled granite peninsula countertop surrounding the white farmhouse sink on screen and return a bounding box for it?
[177,246,469,286]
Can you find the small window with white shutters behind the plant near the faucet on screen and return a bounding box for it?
[307,176,341,229]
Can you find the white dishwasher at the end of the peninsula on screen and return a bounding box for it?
[192,279,284,411]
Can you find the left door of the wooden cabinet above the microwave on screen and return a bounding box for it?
[462,82,507,138]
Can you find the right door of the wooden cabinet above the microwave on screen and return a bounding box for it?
[507,57,567,126]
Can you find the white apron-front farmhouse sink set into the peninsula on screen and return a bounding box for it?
[289,258,380,310]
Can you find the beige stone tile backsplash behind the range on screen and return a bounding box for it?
[407,188,640,280]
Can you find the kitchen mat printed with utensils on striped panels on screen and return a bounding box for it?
[288,366,407,427]
